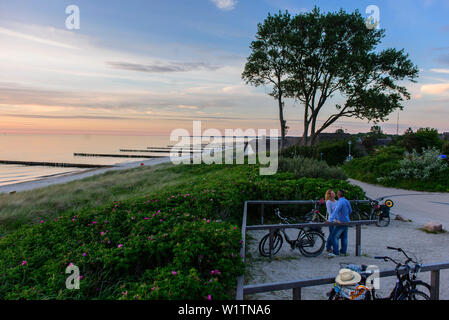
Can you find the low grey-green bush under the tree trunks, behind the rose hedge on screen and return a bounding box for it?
[278,157,348,180]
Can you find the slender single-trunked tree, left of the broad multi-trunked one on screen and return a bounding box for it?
[242,12,291,149]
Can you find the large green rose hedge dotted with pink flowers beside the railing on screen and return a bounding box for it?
[0,165,365,299]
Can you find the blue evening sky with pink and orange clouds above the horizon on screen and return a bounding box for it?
[0,0,449,135]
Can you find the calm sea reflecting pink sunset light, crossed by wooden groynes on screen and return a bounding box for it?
[0,134,170,186]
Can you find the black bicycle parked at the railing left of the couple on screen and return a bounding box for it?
[259,208,326,257]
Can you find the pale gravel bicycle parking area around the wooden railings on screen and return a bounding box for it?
[245,220,449,300]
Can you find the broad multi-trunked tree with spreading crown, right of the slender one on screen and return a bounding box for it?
[244,8,418,144]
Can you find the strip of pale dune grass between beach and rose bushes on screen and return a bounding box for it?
[0,163,206,235]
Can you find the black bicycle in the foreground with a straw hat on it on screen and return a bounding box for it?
[329,247,431,300]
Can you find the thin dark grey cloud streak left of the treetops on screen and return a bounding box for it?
[106,61,218,73]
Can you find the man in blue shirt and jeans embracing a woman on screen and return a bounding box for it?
[329,190,352,256]
